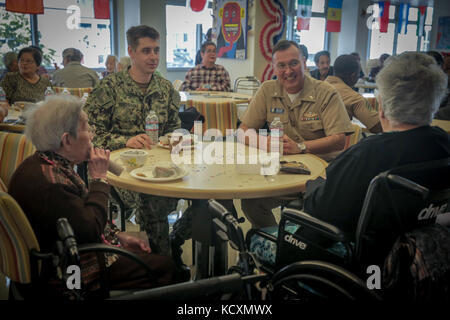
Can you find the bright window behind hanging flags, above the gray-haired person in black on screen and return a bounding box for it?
[369,4,433,59]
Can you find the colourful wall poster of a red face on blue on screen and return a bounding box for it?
[214,0,248,60]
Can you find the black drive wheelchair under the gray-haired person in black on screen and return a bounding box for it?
[246,159,450,300]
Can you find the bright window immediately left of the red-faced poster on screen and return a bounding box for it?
[166,1,213,69]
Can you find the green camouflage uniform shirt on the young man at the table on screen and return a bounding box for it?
[84,70,181,150]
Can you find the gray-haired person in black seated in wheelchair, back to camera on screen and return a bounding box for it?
[247,52,450,298]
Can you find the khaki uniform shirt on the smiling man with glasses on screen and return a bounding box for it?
[241,75,353,160]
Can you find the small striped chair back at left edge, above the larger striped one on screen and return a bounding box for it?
[0,131,36,191]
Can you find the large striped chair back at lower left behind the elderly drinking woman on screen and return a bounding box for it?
[0,192,39,283]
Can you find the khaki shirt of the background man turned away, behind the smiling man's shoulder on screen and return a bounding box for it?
[325,76,380,129]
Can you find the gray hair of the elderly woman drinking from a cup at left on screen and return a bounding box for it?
[25,95,83,151]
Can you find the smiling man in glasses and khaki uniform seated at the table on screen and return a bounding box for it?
[239,40,353,228]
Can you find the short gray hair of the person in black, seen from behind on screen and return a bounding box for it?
[376,52,447,125]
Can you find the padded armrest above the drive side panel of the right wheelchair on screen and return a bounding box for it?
[282,208,350,243]
